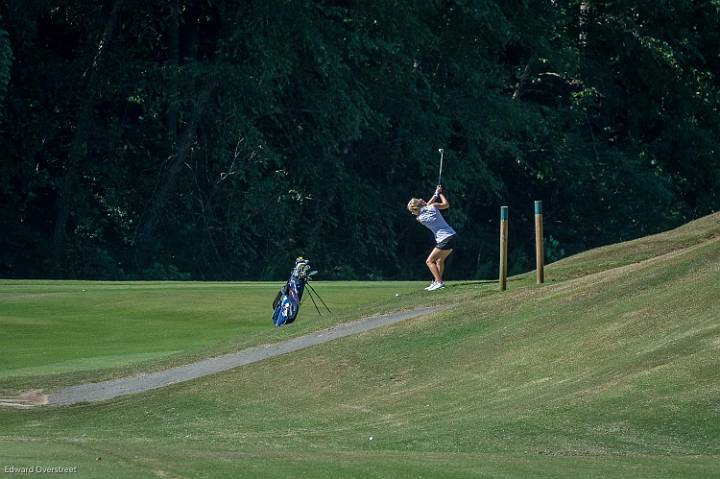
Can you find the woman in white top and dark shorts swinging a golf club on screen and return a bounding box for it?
[408,185,456,291]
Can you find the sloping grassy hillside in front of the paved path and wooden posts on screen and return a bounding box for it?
[0,215,720,478]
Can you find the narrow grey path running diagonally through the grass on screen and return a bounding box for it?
[0,307,444,408]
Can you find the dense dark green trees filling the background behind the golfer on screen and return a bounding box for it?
[0,0,720,279]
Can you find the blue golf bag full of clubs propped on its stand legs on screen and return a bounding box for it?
[273,257,331,327]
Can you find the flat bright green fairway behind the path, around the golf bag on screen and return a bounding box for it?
[0,281,422,392]
